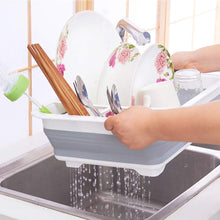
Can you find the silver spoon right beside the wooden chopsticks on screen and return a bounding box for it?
[73,75,103,117]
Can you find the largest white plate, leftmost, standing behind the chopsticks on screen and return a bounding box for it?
[56,11,121,103]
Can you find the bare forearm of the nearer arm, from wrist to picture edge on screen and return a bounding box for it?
[154,101,220,144]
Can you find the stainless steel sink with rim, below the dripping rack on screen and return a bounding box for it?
[0,146,220,220]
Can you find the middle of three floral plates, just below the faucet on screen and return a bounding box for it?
[97,43,140,106]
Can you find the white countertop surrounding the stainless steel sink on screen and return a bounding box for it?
[0,133,220,220]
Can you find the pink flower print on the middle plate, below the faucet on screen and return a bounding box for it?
[109,43,140,68]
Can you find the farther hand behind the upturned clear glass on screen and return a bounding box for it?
[171,51,197,70]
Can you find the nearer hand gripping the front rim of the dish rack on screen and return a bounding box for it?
[104,106,156,150]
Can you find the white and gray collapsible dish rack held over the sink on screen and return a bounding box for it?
[32,77,220,176]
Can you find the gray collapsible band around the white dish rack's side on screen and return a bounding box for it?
[44,129,186,165]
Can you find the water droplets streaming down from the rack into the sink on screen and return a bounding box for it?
[70,165,155,219]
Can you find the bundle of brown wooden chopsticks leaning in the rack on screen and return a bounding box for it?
[28,44,89,115]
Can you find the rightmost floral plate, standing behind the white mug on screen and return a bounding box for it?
[131,44,174,105]
